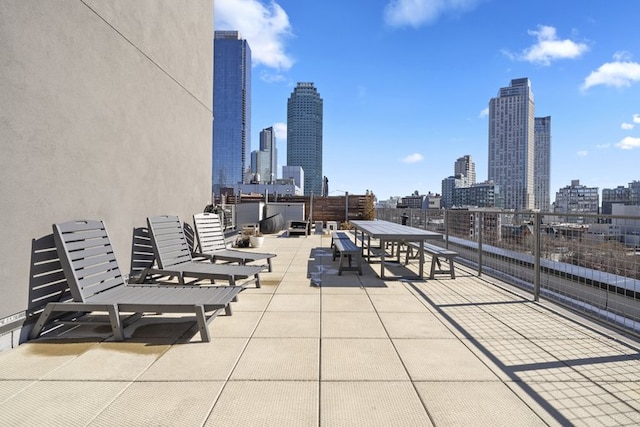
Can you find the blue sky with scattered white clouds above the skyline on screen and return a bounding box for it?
[214,0,640,201]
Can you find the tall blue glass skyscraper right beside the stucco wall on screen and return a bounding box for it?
[212,31,251,194]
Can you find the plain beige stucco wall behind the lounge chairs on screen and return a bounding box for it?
[0,0,213,346]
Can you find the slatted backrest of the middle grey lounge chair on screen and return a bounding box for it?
[147,215,193,269]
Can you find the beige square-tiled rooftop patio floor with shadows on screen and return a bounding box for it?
[0,235,640,427]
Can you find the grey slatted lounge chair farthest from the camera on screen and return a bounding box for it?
[193,212,276,271]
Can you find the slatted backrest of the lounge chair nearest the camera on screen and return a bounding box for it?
[53,220,125,302]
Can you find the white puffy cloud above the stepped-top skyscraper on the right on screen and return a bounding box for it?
[505,25,589,66]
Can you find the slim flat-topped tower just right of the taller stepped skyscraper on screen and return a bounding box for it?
[533,116,551,212]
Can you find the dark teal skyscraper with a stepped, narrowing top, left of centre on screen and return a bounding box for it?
[287,83,323,196]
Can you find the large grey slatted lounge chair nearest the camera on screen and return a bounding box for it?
[30,220,244,341]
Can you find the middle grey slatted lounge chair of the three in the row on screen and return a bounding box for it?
[147,215,263,288]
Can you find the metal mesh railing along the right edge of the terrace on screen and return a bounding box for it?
[376,208,640,334]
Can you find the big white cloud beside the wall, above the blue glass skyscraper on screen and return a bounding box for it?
[214,0,294,70]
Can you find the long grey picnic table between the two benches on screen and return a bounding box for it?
[350,220,443,279]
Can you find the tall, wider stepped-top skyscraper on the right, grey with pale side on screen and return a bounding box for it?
[488,78,535,210]
